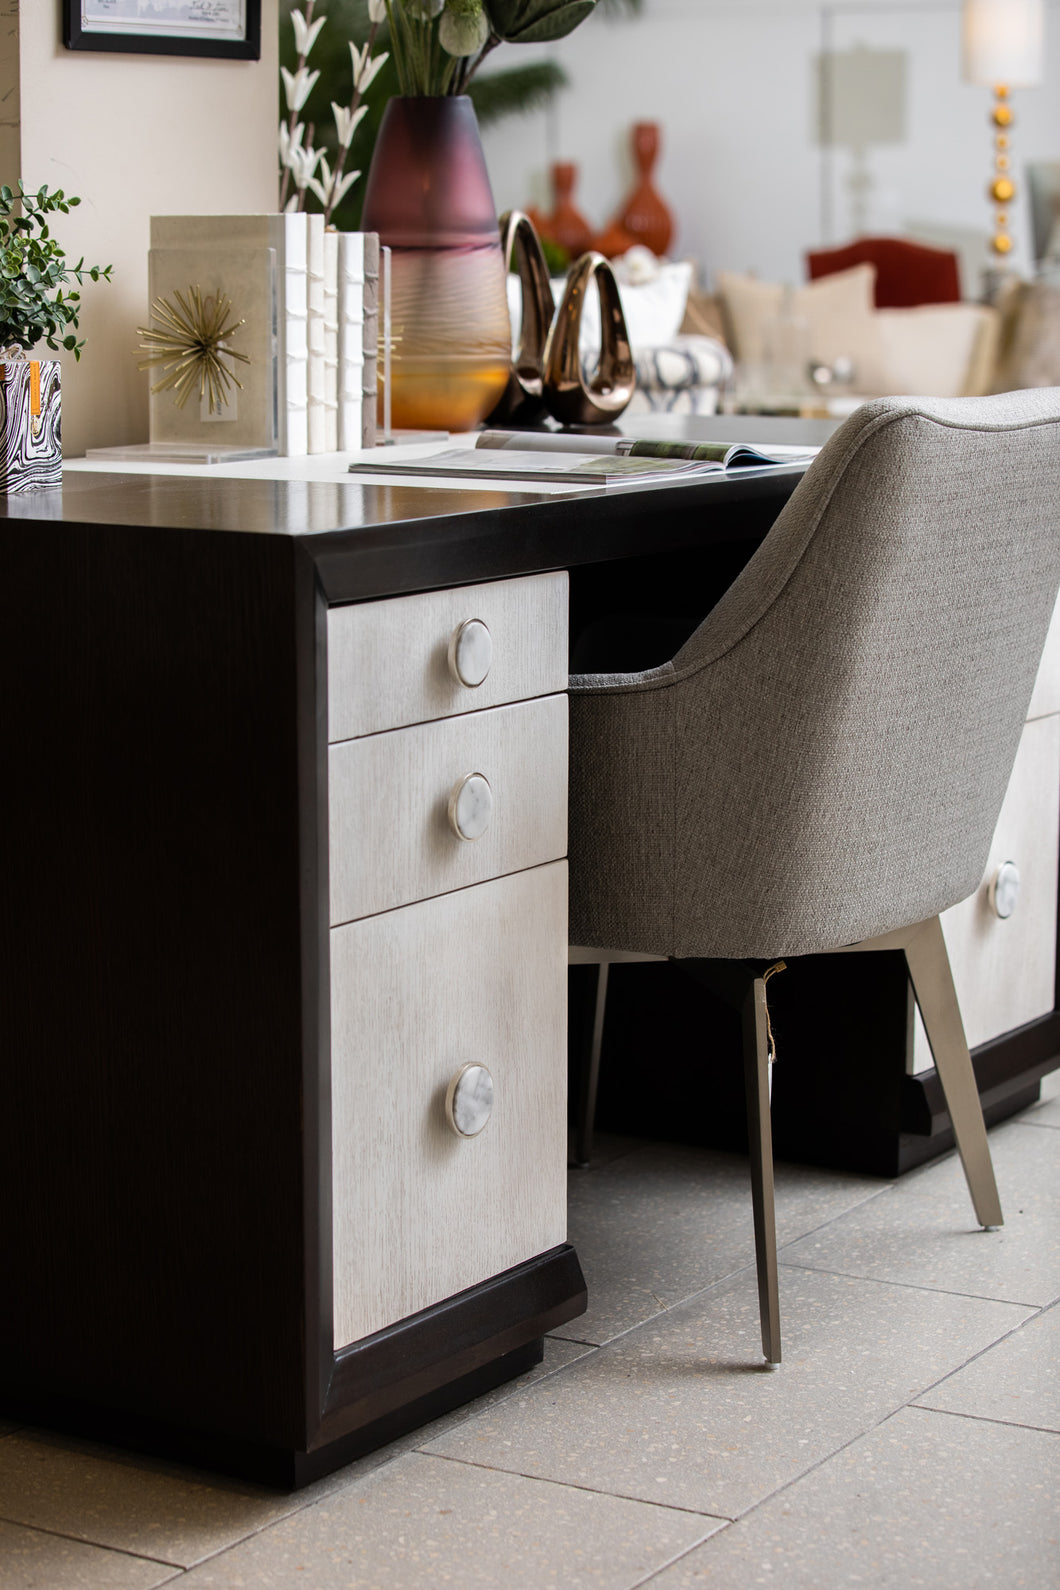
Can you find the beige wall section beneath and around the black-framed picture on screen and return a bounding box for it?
[15,0,278,458]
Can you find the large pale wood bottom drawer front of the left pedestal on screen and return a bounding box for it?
[331,862,567,1348]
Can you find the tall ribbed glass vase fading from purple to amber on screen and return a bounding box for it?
[361,95,512,431]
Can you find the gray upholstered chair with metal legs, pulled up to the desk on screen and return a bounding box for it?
[569,388,1060,1363]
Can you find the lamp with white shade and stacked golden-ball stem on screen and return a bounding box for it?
[961,0,1044,256]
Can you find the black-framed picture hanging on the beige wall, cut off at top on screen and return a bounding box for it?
[62,0,261,60]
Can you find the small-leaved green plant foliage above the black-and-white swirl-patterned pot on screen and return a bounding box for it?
[0,180,114,359]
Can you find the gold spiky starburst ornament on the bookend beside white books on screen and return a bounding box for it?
[137,288,250,413]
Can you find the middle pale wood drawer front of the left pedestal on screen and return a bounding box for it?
[327,695,567,927]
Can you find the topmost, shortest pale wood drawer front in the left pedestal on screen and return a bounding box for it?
[327,571,567,743]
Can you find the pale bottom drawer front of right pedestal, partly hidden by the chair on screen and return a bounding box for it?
[912,714,1060,1072]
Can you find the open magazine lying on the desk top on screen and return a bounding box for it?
[350,431,820,485]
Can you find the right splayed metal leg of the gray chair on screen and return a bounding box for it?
[904,916,1003,1226]
